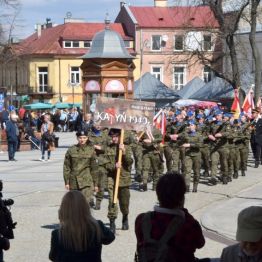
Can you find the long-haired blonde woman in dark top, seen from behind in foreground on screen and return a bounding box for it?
[49,190,115,262]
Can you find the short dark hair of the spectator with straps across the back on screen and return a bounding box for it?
[156,172,186,208]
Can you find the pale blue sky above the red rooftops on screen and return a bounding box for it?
[11,0,154,38]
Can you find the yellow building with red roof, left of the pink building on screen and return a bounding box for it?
[0,19,133,106]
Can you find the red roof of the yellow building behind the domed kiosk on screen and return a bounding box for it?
[13,23,132,56]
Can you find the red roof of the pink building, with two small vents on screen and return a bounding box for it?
[129,6,219,28]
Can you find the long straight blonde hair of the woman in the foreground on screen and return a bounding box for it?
[58,190,101,252]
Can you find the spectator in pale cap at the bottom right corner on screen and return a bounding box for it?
[220,206,262,262]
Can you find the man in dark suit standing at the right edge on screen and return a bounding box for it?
[252,109,262,168]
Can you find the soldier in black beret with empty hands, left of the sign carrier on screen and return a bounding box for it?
[63,130,96,203]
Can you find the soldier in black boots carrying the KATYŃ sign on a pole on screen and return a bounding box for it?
[105,129,133,233]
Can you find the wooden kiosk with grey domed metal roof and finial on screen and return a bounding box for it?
[81,20,135,113]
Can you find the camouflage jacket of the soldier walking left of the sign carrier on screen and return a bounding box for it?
[63,142,96,189]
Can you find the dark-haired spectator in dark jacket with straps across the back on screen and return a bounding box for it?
[135,172,208,262]
